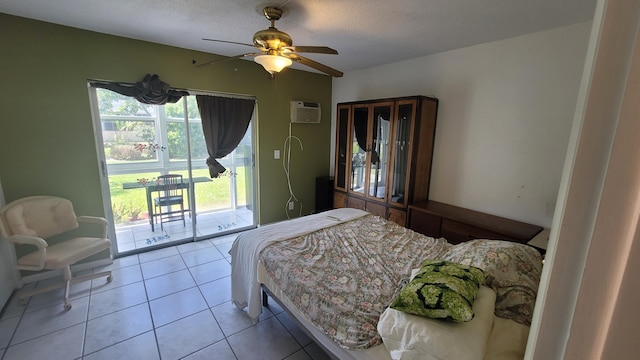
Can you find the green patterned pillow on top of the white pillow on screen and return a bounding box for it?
[390,260,485,322]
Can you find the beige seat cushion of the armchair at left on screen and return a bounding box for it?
[18,237,111,269]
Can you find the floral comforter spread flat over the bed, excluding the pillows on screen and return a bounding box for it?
[260,215,451,349]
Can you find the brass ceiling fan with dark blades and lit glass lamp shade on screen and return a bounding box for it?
[194,6,342,77]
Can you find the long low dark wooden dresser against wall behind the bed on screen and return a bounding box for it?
[407,200,542,244]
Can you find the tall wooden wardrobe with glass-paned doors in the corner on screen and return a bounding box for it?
[333,96,438,226]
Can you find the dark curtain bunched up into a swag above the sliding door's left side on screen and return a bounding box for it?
[93,74,189,105]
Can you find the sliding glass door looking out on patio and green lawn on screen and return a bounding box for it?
[90,87,256,254]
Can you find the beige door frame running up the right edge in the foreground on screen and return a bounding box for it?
[525,0,640,360]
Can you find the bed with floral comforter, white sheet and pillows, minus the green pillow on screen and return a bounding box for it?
[230,208,542,360]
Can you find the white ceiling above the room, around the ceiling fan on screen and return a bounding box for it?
[0,0,596,76]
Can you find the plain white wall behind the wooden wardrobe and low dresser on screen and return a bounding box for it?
[332,22,591,227]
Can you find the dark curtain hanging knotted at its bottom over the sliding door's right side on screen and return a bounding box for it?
[196,95,255,178]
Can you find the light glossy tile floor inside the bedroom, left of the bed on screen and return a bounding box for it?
[0,235,329,360]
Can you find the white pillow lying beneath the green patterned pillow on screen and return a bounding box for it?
[378,285,496,360]
